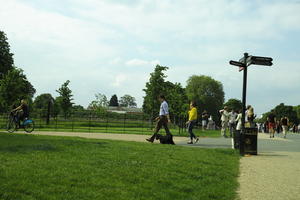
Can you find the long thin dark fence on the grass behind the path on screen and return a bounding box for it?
[0,111,186,135]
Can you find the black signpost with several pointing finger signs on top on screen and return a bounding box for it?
[229,53,273,155]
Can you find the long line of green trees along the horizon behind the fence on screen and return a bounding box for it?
[0,31,300,123]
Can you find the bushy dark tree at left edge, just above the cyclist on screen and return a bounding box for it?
[0,68,36,111]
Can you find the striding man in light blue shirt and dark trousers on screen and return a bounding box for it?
[146,95,172,142]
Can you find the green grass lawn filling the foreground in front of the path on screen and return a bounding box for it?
[0,133,239,200]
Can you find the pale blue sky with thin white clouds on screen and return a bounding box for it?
[0,0,300,115]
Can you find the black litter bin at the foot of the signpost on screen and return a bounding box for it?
[243,128,258,155]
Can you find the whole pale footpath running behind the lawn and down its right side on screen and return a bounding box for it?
[11,132,300,200]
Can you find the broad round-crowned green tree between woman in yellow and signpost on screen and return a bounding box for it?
[186,75,224,122]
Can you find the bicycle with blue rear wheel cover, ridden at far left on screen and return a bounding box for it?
[6,112,34,133]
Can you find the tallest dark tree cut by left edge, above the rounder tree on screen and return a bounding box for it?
[0,31,14,76]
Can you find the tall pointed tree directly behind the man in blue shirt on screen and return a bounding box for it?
[143,65,168,117]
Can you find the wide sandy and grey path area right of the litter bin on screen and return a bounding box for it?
[238,133,300,200]
